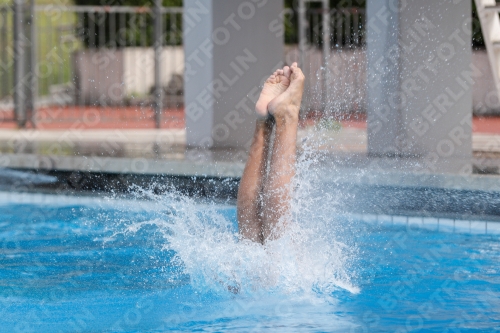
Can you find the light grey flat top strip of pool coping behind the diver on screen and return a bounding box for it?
[0,154,500,191]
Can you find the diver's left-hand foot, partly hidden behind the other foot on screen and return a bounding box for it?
[255,66,291,119]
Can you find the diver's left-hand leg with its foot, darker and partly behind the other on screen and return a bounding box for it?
[237,66,291,243]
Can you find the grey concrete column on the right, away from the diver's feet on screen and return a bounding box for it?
[367,0,472,173]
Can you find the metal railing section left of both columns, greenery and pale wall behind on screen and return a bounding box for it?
[0,1,184,128]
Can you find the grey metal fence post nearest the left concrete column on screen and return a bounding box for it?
[153,0,163,128]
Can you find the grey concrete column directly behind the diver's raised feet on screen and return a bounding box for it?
[183,0,284,148]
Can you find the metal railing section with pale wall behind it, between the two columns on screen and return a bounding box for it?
[294,1,366,116]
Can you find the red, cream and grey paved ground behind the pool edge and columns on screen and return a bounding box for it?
[0,107,500,173]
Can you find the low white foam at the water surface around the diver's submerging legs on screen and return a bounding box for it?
[110,185,359,294]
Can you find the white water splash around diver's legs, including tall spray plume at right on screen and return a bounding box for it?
[103,137,359,295]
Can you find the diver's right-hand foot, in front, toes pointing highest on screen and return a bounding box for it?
[268,62,305,123]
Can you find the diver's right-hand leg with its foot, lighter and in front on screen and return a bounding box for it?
[262,63,305,242]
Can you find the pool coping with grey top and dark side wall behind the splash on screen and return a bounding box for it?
[0,154,500,221]
